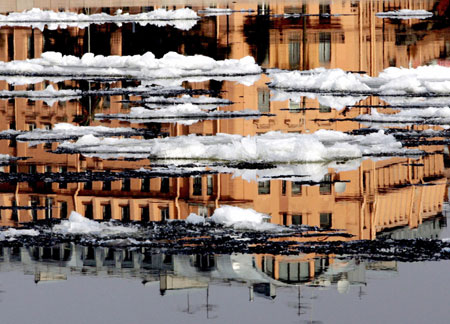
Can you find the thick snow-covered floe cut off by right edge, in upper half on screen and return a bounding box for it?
[269,65,450,108]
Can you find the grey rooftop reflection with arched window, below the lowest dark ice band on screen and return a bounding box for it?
[0,213,442,300]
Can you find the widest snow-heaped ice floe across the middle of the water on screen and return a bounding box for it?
[57,130,416,163]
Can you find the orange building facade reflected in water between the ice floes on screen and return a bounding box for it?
[0,1,444,243]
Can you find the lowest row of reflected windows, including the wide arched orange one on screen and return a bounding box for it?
[0,244,330,283]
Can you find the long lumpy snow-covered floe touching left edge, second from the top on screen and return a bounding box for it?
[0,52,261,85]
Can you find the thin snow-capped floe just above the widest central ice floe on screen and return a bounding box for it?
[95,103,265,125]
